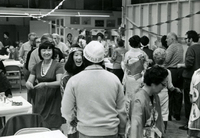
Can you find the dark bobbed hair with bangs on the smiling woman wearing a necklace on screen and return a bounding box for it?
[38,41,55,60]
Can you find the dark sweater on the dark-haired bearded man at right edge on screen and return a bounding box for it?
[183,44,200,79]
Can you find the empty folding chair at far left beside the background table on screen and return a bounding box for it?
[5,65,22,93]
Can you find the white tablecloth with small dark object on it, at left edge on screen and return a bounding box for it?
[0,96,32,120]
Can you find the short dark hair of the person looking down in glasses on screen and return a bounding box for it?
[144,65,168,86]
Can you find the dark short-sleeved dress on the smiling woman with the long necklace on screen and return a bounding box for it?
[31,61,64,128]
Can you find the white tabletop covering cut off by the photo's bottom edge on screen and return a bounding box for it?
[1,130,67,138]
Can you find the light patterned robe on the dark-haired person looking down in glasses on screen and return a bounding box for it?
[126,89,164,138]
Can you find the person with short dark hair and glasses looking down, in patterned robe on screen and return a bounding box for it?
[128,66,168,138]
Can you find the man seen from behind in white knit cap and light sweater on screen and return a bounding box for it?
[61,41,127,138]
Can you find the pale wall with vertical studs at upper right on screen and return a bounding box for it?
[125,0,200,44]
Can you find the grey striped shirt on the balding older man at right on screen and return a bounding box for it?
[165,43,184,68]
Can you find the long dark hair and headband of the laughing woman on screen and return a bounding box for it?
[65,44,84,75]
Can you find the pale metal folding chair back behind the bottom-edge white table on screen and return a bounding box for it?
[14,127,51,135]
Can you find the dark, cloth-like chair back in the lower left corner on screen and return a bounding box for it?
[0,113,45,137]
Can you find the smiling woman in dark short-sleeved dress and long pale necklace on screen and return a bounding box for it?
[26,42,64,129]
